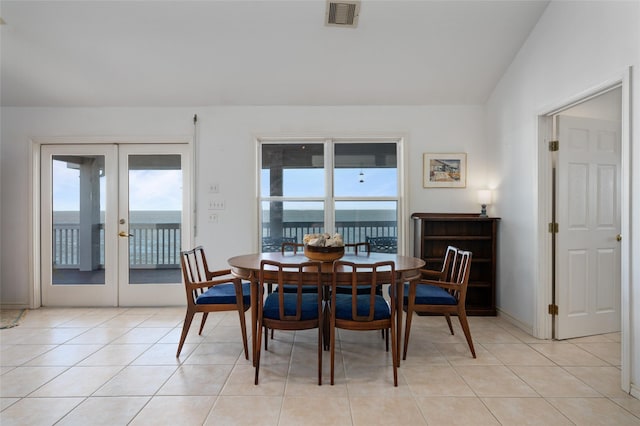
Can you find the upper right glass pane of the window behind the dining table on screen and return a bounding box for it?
[333,143,398,197]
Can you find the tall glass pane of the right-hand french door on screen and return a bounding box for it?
[129,155,183,284]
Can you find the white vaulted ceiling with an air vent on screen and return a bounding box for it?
[0,0,548,107]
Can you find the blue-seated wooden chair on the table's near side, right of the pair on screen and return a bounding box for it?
[325,260,398,386]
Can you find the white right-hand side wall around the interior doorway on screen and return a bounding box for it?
[487,1,640,392]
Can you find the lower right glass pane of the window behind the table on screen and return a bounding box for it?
[336,201,398,253]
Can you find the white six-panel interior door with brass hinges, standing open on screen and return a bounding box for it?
[556,116,621,339]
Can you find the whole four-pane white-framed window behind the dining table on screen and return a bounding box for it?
[259,139,401,252]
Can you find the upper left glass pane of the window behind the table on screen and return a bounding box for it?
[260,143,325,198]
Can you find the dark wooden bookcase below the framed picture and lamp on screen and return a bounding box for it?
[411,213,500,315]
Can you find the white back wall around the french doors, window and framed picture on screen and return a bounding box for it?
[0,106,493,305]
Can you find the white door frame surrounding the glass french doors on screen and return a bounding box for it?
[27,136,195,309]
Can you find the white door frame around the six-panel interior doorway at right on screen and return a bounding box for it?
[534,68,631,392]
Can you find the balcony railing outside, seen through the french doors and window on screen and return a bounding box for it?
[53,221,398,269]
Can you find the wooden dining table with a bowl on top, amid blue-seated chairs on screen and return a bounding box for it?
[227,252,425,364]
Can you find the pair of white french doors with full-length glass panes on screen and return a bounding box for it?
[40,144,191,306]
